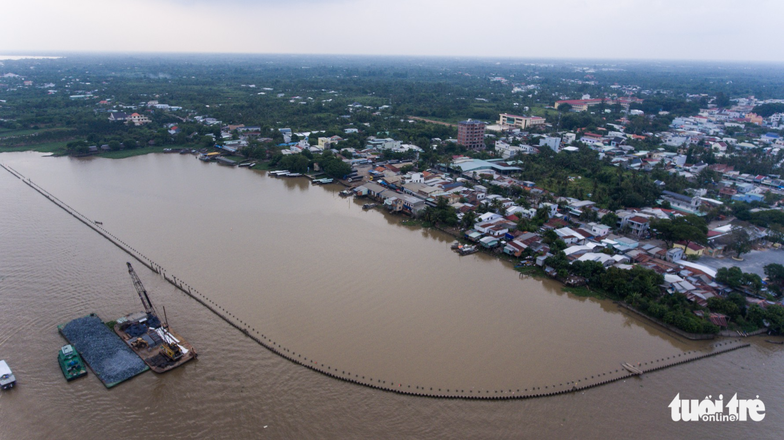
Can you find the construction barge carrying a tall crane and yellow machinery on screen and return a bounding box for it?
[114,263,197,373]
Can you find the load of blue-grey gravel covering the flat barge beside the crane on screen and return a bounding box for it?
[58,313,149,388]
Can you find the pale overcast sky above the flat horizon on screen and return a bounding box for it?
[0,0,784,62]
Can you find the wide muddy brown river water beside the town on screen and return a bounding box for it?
[0,153,784,438]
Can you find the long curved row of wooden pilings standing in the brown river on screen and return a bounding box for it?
[0,164,749,400]
